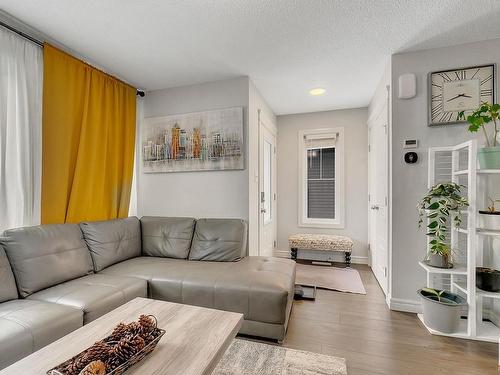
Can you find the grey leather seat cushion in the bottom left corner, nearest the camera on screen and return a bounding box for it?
[0,300,83,369]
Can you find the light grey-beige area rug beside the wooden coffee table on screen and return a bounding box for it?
[212,339,347,375]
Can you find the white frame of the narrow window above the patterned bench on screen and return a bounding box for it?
[298,128,345,229]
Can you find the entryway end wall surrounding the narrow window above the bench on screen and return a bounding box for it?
[277,108,368,262]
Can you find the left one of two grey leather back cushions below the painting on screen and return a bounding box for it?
[141,216,196,259]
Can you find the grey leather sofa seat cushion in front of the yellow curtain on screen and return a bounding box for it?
[28,274,147,324]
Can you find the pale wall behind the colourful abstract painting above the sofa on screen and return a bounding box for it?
[137,77,249,220]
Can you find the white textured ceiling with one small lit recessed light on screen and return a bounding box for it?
[0,0,500,114]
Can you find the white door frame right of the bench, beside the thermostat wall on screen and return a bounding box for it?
[367,85,392,300]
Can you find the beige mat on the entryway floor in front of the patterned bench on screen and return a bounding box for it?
[295,263,366,294]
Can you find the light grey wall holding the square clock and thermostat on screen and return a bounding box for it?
[391,39,500,307]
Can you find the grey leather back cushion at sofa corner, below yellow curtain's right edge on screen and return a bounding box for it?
[80,217,141,272]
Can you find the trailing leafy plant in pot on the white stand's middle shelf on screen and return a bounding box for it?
[417,182,469,268]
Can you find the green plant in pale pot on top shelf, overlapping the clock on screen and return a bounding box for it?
[459,103,500,169]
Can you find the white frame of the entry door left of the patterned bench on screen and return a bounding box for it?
[257,109,278,256]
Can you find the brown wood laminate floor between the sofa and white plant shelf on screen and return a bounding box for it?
[272,265,500,375]
